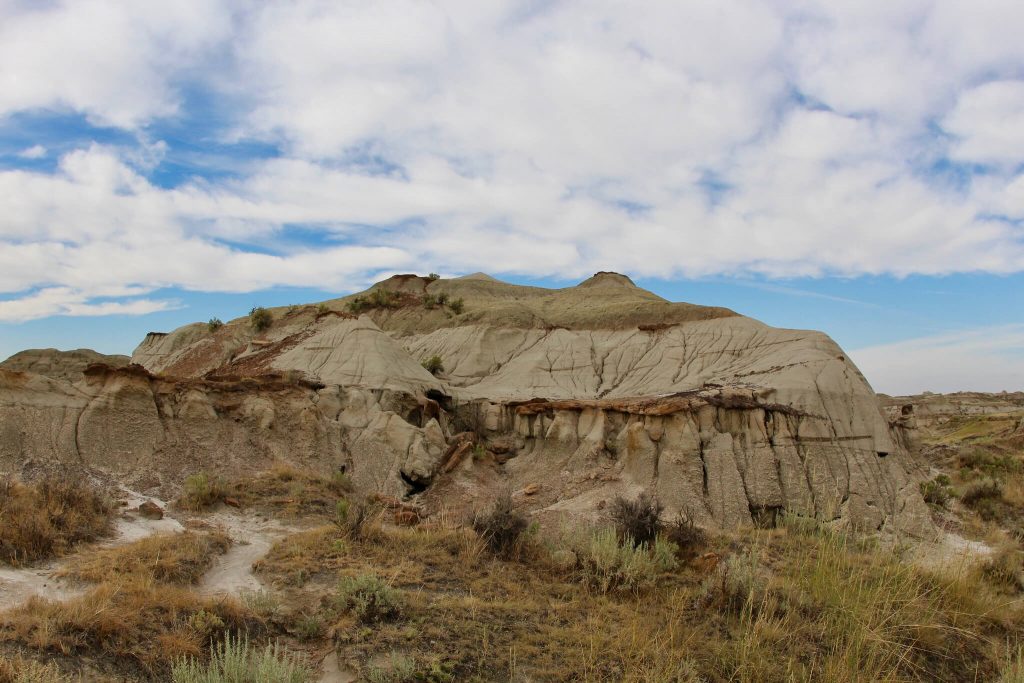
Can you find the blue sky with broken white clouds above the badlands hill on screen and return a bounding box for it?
[0,0,1024,393]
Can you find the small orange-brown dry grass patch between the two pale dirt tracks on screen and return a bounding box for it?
[62,531,231,586]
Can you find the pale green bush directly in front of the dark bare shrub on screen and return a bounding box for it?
[577,527,663,593]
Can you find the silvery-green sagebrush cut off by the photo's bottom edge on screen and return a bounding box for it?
[171,636,312,683]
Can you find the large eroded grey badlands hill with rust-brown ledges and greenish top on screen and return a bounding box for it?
[0,272,930,533]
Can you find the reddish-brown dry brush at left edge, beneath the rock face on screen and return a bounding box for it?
[0,477,113,565]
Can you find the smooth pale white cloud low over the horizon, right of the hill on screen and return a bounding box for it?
[849,325,1024,394]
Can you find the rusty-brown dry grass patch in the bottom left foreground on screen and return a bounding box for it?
[0,579,261,676]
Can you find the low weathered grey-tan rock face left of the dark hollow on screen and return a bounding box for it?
[0,366,444,496]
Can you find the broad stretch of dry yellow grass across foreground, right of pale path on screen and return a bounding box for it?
[247,516,1024,682]
